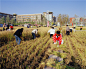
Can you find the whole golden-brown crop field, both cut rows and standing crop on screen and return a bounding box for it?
[0,26,86,69]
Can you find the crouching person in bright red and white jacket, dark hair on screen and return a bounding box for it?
[53,31,63,47]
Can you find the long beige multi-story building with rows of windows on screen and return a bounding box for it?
[16,14,42,22]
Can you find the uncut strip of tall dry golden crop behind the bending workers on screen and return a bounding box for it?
[0,27,50,46]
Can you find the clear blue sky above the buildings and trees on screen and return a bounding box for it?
[0,0,86,17]
